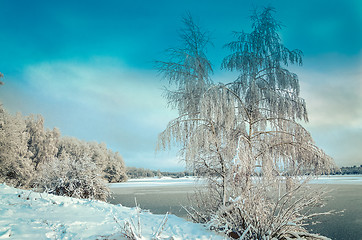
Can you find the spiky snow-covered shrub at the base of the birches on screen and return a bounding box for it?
[186,177,333,240]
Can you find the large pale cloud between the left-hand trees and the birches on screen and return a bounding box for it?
[18,58,182,170]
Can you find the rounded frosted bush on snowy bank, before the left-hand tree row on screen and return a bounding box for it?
[37,156,110,201]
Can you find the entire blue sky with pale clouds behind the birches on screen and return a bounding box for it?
[0,0,362,171]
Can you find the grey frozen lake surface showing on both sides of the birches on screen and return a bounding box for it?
[109,175,362,240]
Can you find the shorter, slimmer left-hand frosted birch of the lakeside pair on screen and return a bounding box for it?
[158,16,236,207]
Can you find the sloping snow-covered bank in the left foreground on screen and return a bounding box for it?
[0,184,223,240]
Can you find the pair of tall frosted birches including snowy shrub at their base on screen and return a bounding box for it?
[159,8,334,239]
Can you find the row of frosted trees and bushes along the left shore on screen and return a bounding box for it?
[0,100,127,196]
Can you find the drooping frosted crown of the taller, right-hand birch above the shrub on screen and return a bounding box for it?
[220,8,334,184]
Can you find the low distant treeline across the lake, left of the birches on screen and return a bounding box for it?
[127,167,193,178]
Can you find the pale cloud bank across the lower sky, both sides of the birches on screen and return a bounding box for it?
[12,58,362,170]
